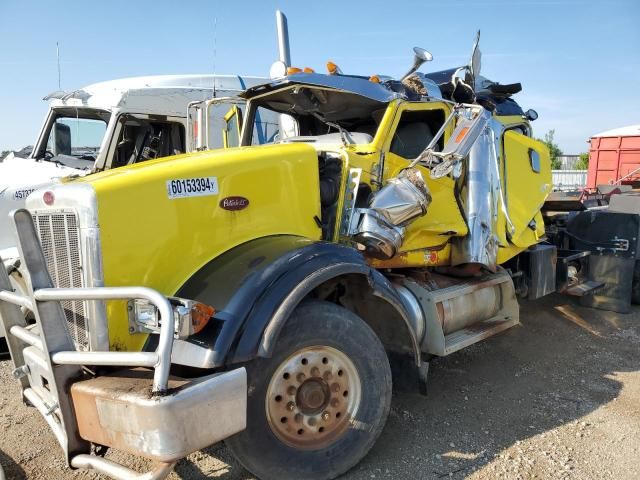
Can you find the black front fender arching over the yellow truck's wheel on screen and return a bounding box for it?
[176,235,420,367]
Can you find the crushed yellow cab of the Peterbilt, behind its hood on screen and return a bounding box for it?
[235,73,551,268]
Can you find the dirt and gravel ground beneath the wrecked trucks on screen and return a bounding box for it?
[0,296,640,480]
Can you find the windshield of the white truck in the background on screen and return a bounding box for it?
[36,109,110,169]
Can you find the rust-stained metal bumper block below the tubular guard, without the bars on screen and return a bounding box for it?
[71,368,247,463]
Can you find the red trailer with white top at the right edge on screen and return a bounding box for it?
[587,125,640,188]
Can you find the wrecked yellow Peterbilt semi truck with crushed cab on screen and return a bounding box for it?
[0,42,555,479]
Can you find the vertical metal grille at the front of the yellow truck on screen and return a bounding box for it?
[33,211,89,350]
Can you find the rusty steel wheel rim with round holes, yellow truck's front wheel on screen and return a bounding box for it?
[265,346,362,450]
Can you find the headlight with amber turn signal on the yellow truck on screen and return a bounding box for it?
[128,297,216,338]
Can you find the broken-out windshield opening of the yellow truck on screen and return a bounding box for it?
[243,86,386,145]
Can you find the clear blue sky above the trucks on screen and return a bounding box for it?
[0,0,640,153]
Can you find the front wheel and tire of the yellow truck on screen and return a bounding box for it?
[226,300,391,480]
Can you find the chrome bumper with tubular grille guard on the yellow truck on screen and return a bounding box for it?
[0,210,247,480]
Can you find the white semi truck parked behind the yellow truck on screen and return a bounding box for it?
[0,75,267,296]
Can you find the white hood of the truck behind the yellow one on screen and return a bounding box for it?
[0,155,89,255]
